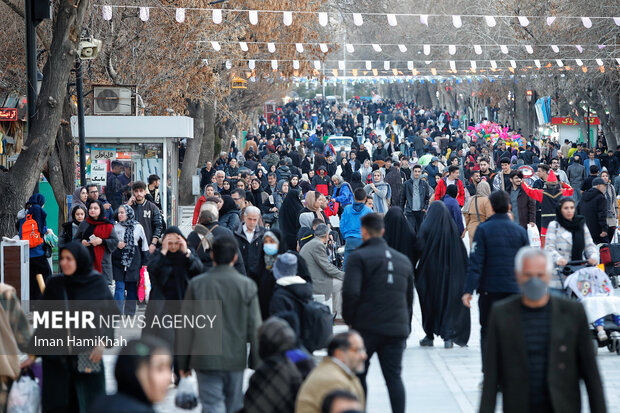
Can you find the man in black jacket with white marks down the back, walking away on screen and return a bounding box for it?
[342,213,413,413]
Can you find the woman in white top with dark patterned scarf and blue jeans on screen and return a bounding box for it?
[112,205,149,315]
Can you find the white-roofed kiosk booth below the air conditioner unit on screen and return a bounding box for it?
[71,116,194,226]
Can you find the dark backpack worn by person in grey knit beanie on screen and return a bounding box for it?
[300,300,334,353]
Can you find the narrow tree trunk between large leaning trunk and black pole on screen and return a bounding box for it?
[43,99,75,227]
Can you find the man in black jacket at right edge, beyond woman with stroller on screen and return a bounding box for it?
[579,178,608,244]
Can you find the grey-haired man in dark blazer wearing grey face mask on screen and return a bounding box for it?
[480,247,607,413]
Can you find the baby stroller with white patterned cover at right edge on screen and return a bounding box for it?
[556,261,620,355]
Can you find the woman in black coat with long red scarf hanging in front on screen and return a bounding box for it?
[74,200,118,285]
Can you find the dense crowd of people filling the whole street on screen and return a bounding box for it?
[0,100,620,413]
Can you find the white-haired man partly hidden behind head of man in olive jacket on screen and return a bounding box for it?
[187,202,246,275]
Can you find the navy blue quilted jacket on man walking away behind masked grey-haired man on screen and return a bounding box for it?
[465,214,530,294]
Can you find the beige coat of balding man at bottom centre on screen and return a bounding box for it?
[295,356,366,413]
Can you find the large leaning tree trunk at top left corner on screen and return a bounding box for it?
[0,0,90,237]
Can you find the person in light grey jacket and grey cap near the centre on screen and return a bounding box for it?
[299,224,344,323]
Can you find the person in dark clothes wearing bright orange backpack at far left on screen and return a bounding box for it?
[17,194,52,300]
